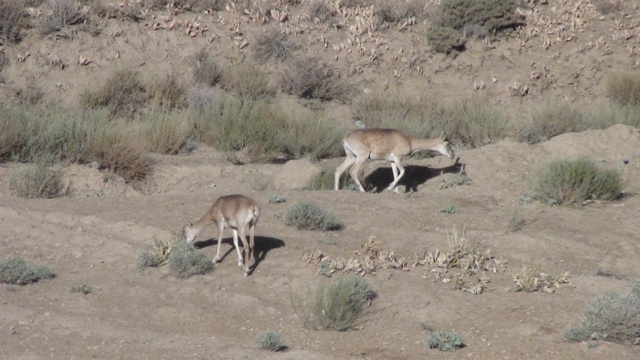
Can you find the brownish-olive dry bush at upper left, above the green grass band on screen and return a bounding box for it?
[80,69,147,117]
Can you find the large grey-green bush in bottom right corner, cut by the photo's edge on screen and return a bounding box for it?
[565,281,640,345]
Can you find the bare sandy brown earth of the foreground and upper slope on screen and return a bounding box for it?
[0,1,640,359]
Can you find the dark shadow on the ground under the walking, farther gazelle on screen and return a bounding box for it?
[364,157,464,193]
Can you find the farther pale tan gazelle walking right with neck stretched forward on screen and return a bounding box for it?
[334,129,455,193]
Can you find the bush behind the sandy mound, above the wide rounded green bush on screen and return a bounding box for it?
[518,105,586,144]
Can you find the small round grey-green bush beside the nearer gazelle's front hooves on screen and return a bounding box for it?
[169,241,213,279]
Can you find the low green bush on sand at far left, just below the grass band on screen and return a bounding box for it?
[9,162,65,199]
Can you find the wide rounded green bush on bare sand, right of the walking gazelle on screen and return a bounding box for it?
[532,158,622,206]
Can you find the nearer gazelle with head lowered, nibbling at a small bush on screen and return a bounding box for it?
[182,194,260,276]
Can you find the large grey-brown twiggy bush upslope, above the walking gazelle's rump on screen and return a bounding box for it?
[280,57,353,101]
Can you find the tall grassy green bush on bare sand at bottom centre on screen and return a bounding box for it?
[304,275,376,331]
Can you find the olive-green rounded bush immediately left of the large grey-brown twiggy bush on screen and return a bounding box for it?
[220,63,275,100]
